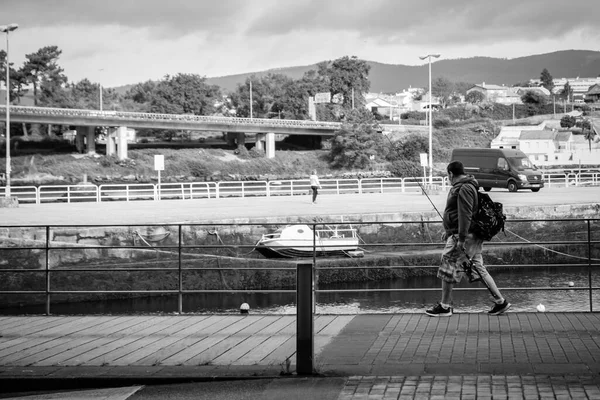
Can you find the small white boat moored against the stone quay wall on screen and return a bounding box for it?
[255,225,358,258]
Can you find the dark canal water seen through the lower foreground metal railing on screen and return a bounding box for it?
[0,267,600,315]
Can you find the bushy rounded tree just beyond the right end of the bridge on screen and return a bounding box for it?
[329,108,389,168]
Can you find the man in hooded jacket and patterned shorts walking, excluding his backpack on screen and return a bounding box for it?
[425,161,510,317]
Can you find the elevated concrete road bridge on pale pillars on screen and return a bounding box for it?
[0,106,341,159]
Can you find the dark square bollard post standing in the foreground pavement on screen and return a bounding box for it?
[296,263,315,375]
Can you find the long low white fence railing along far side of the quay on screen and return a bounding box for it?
[0,170,600,204]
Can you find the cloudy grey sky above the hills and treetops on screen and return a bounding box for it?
[0,0,600,87]
